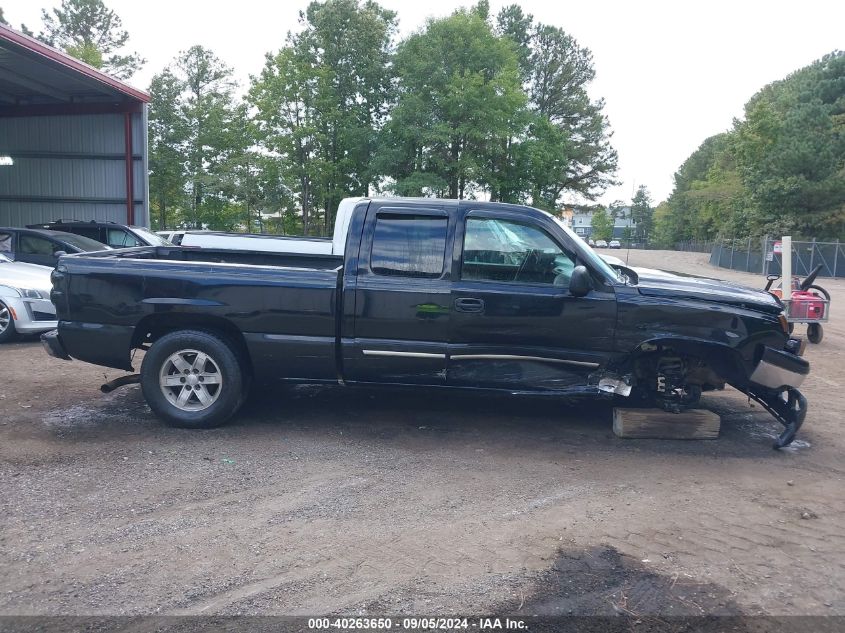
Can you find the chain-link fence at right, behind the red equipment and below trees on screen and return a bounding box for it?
[710,237,845,277]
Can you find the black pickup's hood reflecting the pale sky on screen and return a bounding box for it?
[634,268,783,314]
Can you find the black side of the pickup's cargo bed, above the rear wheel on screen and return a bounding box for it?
[51,246,343,380]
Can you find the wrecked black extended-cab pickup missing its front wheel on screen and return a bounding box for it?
[42,198,809,447]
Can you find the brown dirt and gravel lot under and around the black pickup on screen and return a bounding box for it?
[0,252,845,615]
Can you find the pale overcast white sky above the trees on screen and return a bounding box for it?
[0,0,845,204]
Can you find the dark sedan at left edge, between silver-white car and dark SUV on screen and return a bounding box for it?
[0,228,109,268]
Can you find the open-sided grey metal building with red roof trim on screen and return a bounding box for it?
[0,24,150,226]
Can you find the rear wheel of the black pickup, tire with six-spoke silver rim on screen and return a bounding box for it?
[141,330,245,429]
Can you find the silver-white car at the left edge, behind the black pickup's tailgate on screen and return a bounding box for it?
[0,254,58,343]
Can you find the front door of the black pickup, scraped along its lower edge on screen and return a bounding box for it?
[447,209,616,391]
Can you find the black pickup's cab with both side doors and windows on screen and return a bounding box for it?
[341,199,616,391]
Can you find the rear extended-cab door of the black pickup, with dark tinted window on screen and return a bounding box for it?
[341,200,454,385]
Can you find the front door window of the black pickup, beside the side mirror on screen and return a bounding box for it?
[461,217,575,286]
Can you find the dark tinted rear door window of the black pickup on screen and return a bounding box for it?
[370,213,448,279]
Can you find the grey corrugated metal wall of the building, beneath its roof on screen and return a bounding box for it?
[0,112,149,226]
